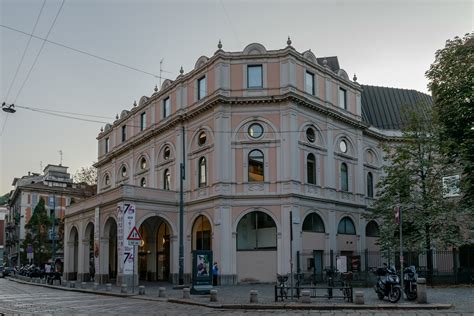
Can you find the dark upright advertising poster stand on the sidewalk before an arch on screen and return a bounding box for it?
[191,250,212,294]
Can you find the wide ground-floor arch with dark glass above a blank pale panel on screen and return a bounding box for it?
[237,211,277,282]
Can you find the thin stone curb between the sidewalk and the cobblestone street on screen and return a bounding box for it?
[7,277,454,310]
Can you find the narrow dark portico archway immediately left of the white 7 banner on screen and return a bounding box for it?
[101,217,118,282]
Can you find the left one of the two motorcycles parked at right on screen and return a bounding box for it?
[374,267,402,303]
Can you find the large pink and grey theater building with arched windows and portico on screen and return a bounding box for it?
[64,40,429,284]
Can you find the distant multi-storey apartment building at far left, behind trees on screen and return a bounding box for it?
[5,164,95,266]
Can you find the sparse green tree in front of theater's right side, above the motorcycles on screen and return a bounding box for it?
[368,112,469,282]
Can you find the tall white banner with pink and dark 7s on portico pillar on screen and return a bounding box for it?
[117,203,135,275]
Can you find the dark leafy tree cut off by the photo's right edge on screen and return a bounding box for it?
[426,33,474,210]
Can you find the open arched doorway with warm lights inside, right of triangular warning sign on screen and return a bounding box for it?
[137,216,172,281]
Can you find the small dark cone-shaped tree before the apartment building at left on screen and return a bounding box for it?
[25,198,53,264]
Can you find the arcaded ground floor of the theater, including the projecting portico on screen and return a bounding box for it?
[64,185,379,284]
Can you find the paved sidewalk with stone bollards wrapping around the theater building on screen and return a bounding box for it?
[9,277,466,312]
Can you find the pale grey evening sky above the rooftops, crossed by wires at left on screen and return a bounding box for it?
[0,0,474,195]
